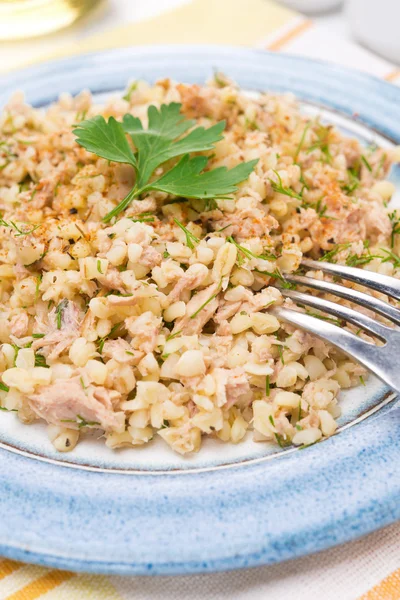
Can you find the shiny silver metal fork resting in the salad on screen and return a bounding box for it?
[271,259,400,392]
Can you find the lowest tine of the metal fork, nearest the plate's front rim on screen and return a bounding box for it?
[269,306,381,374]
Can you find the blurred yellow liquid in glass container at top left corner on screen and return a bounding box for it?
[0,0,99,41]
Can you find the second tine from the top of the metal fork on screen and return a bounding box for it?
[285,274,400,325]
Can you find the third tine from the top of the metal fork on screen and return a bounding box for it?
[281,290,392,341]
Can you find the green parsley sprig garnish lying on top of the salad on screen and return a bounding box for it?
[74,102,258,223]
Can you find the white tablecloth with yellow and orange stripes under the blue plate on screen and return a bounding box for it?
[0,0,400,600]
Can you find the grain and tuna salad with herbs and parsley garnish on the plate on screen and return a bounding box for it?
[0,74,400,454]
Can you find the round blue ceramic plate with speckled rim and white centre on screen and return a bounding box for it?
[0,46,400,574]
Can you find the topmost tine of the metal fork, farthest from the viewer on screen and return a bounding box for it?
[301,258,400,300]
